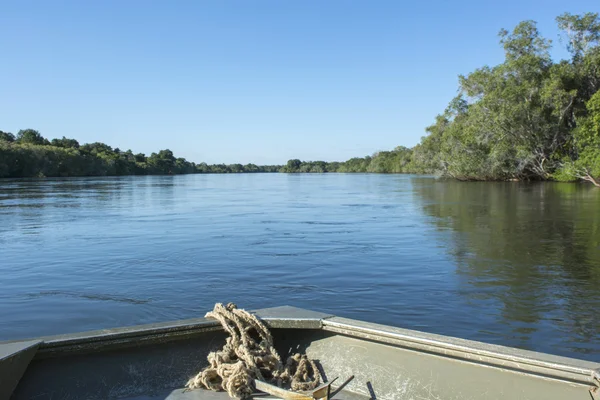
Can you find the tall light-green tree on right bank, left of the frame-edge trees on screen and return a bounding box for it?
[458,21,562,179]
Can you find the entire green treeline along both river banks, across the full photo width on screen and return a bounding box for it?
[0,13,600,186]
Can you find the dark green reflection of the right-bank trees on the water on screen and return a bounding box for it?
[413,178,600,352]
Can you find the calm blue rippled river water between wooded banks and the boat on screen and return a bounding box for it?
[0,174,600,361]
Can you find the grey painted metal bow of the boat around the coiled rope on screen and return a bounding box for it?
[2,307,600,400]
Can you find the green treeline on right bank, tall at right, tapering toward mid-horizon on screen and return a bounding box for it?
[284,13,600,186]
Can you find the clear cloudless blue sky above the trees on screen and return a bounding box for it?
[0,0,600,164]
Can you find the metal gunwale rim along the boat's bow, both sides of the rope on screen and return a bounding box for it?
[0,306,600,386]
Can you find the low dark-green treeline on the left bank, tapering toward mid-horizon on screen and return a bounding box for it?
[0,129,281,178]
